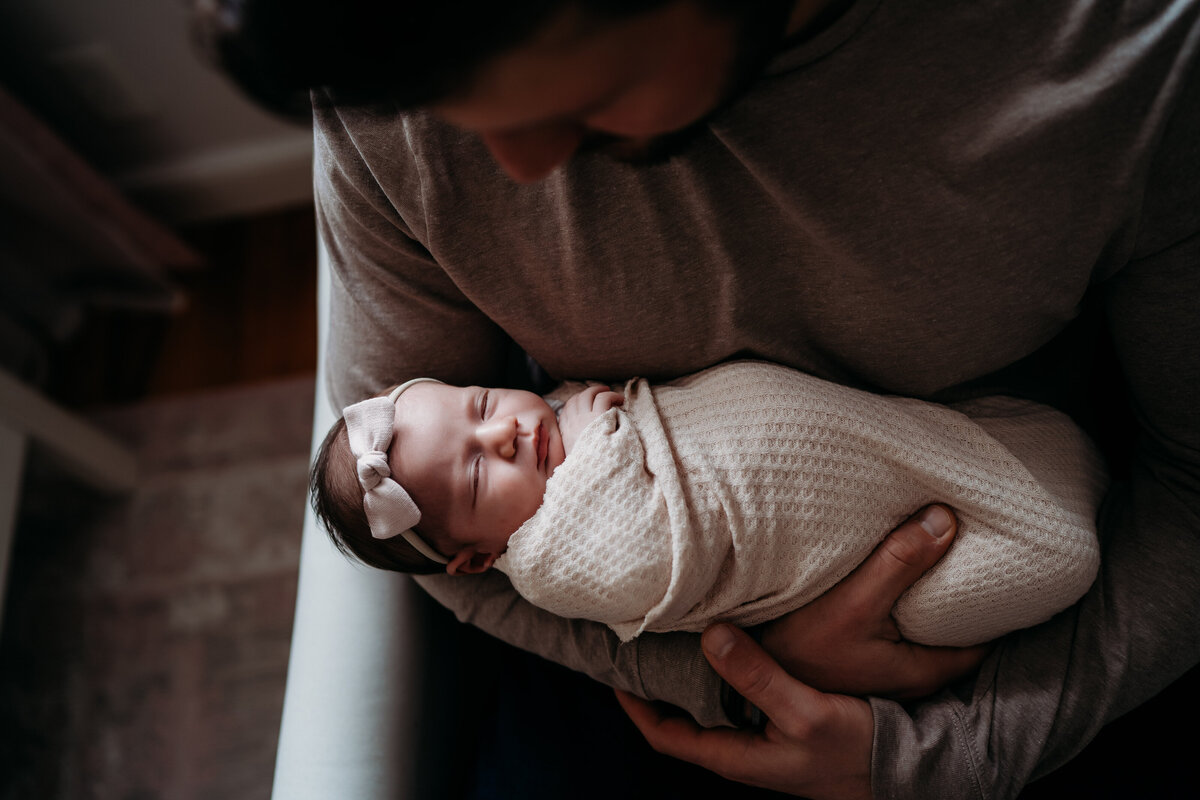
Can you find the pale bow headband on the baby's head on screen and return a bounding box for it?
[342,378,446,564]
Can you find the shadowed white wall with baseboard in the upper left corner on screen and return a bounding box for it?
[0,0,312,222]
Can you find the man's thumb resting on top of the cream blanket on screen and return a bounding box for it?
[844,505,958,616]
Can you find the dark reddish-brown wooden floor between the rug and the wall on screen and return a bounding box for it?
[47,207,317,408]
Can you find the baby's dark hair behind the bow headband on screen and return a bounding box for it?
[308,419,445,575]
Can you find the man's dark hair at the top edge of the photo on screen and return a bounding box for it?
[184,0,686,120]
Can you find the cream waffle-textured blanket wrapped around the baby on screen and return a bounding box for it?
[497,361,1105,645]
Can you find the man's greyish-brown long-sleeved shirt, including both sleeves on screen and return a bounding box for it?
[316,0,1200,798]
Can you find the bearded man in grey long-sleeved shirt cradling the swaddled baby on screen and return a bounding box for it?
[199,0,1200,798]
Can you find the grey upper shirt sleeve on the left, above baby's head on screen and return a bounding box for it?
[313,92,508,408]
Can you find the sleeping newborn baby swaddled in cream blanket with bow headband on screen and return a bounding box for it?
[313,361,1104,645]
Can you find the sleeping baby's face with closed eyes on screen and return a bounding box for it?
[389,383,566,559]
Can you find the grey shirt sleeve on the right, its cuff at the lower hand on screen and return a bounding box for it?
[871,53,1200,799]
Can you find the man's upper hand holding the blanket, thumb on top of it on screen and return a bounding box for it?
[762,505,989,699]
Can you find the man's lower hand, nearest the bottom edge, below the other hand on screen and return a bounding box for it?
[617,624,874,800]
